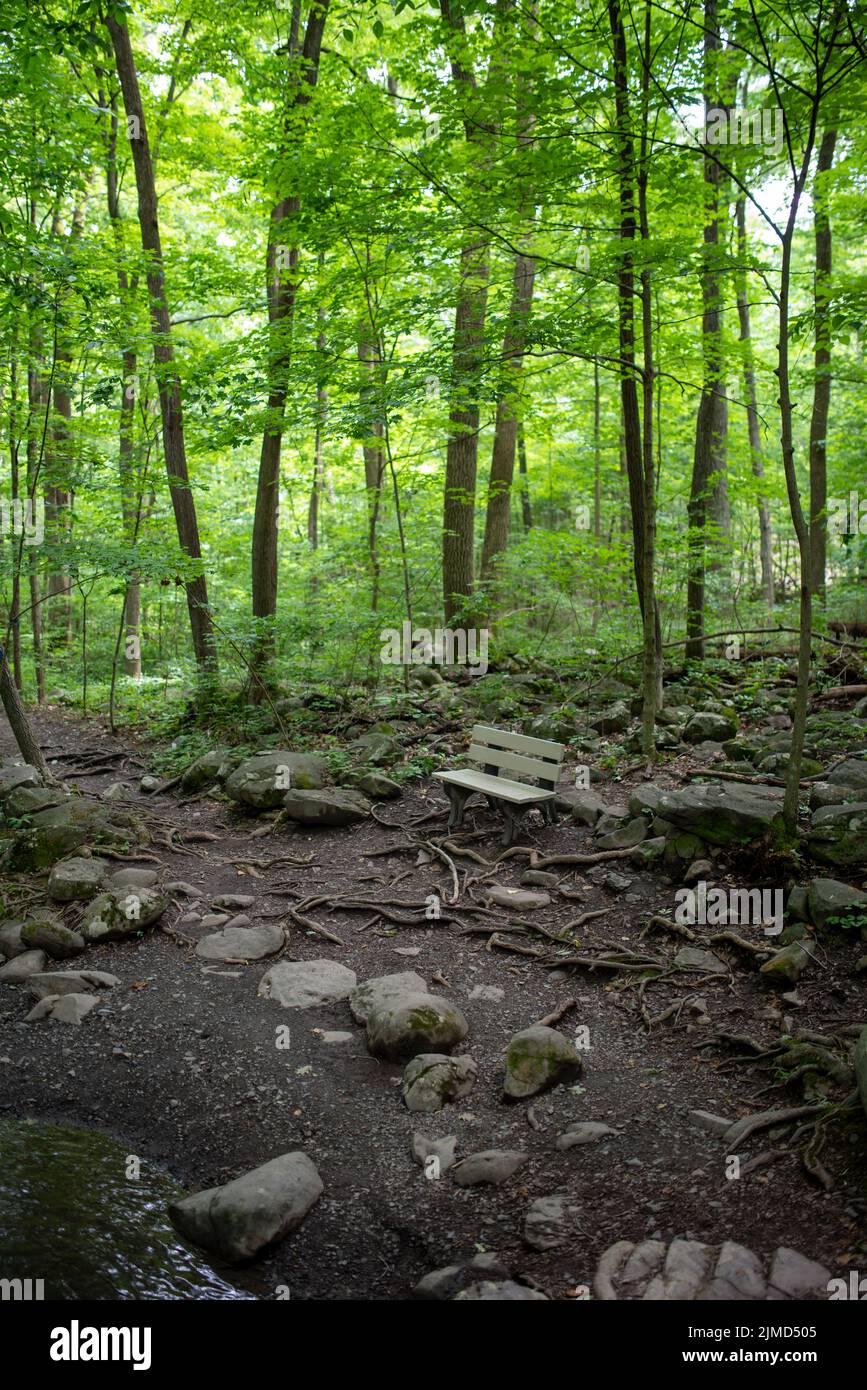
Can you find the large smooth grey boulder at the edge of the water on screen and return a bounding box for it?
[168,1151,324,1264]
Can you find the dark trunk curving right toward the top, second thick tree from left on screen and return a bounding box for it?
[251,0,329,672]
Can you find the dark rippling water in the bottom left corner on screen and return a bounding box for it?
[0,1119,257,1300]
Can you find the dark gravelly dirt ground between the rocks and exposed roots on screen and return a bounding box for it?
[0,710,867,1300]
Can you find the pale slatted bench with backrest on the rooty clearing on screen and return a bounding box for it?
[434,724,565,845]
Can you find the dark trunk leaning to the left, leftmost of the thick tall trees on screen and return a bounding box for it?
[106,10,217,671]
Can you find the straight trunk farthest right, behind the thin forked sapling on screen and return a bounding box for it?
[810,129,836,603]
